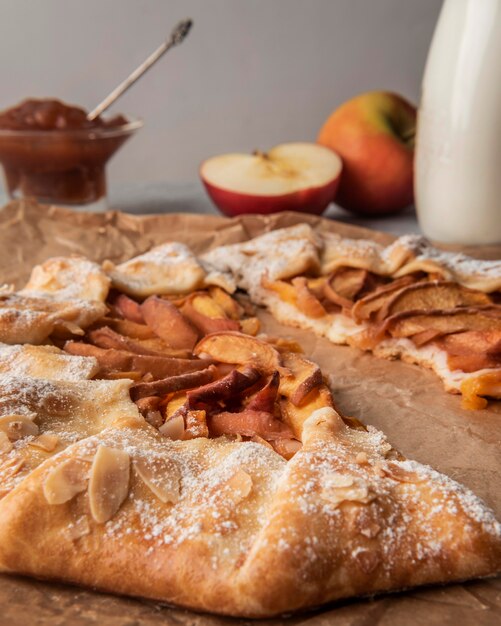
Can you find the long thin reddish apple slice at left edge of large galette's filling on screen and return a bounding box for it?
[64,341,212,379]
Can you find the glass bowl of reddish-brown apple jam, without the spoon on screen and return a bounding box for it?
[0,99,143,211]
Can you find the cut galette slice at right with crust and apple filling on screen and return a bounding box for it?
[210,229,501,409]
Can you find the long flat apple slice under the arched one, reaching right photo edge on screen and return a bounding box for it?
[382,305,501,337]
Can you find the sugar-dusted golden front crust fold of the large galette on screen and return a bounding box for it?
[0,409,501,617]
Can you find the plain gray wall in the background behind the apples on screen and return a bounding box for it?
[0,0,441,182]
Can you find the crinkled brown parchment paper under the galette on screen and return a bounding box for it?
[0,201,501,626]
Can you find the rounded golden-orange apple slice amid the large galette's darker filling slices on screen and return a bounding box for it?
[193,331,280,374]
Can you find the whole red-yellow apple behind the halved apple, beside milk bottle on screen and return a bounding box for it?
[318,91,416,215]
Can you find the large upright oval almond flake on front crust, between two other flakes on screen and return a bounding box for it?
[89,446,130,524]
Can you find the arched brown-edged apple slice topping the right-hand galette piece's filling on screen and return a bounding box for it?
[376,280,492,321]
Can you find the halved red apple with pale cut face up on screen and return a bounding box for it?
[200,143,342,216]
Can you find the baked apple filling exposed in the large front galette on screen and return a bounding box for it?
[62,286,332,459]
